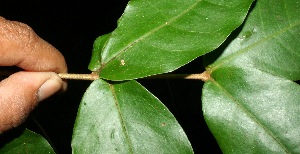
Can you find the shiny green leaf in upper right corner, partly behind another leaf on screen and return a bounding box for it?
[209,1,300,80]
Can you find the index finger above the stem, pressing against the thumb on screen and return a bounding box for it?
[0,17,67,73]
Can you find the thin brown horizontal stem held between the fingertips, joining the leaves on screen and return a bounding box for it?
[0,70,211,82]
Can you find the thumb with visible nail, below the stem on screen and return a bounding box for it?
[0,72,66,134]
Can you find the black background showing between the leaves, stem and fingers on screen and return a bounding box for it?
[0,0,220,154]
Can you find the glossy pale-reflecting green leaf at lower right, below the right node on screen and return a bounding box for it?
[203,68,300,153]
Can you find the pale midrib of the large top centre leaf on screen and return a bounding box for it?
[101,0,203,68]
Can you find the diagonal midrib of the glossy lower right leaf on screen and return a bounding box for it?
[211,80,289,153]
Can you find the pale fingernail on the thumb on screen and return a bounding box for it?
[37,75,64,102]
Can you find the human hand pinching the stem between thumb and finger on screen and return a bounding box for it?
[0,17,67,134]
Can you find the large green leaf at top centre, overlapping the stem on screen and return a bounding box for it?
[94,0,253,80]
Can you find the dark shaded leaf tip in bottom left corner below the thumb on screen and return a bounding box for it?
[0,129,55,154]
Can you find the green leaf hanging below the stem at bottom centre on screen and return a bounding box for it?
[72,80,193,153]
